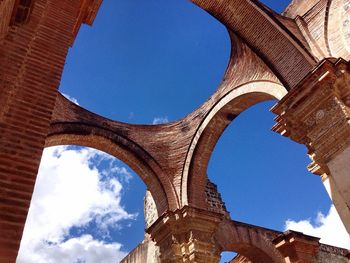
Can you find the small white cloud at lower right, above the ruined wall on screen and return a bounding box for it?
[285,205,350,249]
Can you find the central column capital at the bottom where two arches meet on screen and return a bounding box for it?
[147,207,222,263]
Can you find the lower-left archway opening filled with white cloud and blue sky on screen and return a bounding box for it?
[17,146,146,263]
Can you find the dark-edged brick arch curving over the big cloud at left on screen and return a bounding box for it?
[45,95,178,215]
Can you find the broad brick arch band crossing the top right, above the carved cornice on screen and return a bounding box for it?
[192,0,317,89]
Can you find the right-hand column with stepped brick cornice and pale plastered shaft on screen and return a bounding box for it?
[271,59,350,233]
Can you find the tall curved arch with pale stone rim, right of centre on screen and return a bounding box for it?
[181,81,286,209]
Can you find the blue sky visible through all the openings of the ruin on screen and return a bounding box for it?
[18,0,347,263]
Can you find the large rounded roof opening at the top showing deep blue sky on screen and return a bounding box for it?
[60,0,231,124]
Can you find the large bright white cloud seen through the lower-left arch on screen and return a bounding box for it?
[17,146,136,263]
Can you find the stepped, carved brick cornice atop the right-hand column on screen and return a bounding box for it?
[271,59,350,175]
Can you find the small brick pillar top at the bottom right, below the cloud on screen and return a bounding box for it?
[273,231,320,263]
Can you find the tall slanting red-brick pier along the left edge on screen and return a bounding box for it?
[0,0,87,263]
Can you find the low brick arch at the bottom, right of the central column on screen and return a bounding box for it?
[215,221,285,263]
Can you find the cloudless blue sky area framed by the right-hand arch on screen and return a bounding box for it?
[207,101,331,262]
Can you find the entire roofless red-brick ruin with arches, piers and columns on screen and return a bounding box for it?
[0,0,350,263]
